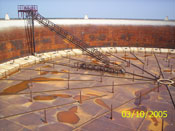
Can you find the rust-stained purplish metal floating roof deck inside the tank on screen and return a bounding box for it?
[0,52,175,131]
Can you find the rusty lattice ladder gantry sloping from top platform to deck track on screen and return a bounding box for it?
[18,5,125,73]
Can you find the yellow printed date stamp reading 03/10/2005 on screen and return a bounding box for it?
[121,110,168,118]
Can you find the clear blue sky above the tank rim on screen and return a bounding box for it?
[0,0,175,20]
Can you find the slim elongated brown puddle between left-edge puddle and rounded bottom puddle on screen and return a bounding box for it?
[33,94,72,101]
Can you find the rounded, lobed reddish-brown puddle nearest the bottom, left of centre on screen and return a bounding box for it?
[57,106,80,124]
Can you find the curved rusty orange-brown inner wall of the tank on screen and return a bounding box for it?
[0,18,175,63]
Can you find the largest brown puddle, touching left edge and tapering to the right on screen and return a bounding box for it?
[0,77,63,95]
